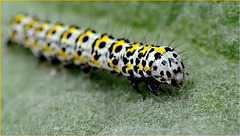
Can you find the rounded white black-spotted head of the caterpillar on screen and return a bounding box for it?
[151,47,185,86]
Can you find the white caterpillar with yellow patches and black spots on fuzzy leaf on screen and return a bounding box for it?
[8,13,186,96]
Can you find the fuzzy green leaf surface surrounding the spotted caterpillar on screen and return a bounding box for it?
[1,1,239,135]
